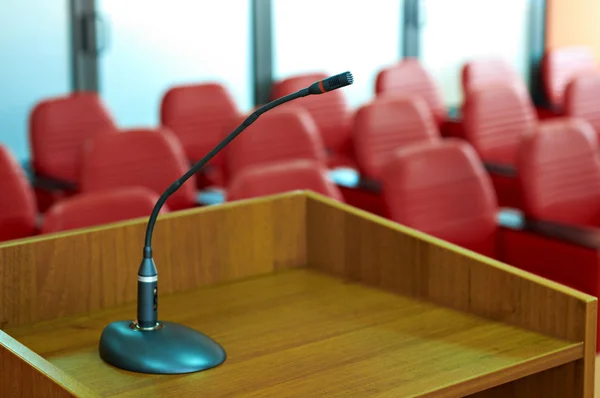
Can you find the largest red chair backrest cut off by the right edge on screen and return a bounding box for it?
[517,118,600,227]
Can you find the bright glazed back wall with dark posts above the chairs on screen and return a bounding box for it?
[0,0,600,162]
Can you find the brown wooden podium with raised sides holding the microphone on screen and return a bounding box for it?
[0,192,597,398]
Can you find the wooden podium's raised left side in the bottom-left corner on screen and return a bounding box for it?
[0,330,98,398]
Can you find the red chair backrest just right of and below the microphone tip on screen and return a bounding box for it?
[353,96,441,180]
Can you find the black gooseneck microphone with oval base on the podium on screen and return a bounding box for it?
[99,72,354,374]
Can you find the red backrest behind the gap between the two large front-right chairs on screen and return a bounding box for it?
[463,86,537,165]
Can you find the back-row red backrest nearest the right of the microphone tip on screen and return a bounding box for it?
[375,58,446,125]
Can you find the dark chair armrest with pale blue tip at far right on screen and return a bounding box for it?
[498,211,600,250]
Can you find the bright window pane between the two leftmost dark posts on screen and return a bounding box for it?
[98,0,253,127]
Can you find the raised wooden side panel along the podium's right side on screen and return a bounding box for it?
[306,193,597,397]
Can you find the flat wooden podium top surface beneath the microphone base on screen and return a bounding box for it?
[7,269,583,397]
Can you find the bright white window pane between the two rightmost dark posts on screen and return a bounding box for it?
[421,0,531,106]
